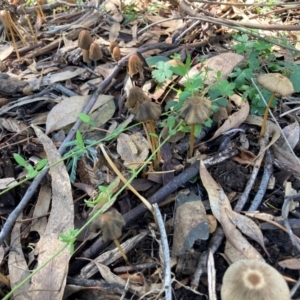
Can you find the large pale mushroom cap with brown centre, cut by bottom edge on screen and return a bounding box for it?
[221,259,290,300]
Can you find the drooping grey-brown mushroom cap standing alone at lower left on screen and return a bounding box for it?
[100,209,126,242]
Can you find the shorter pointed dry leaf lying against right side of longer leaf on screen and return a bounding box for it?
[225,209,270,256]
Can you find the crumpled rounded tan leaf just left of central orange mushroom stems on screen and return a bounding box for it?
[117,133,149,169]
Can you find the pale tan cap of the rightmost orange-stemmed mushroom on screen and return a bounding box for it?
[257,73,294,96]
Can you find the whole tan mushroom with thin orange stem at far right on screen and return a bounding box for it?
[257,73,294,138]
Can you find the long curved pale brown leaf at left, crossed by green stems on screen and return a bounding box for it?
[29,126,74,300]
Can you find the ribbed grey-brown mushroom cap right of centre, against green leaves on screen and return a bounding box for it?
[179,97,212,125]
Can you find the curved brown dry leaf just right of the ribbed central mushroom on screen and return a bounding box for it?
[209,101,250,141]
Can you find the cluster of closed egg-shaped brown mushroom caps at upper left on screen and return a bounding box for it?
[78,30,121,67]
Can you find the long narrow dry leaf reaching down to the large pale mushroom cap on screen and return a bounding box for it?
[200,161,262,259]
